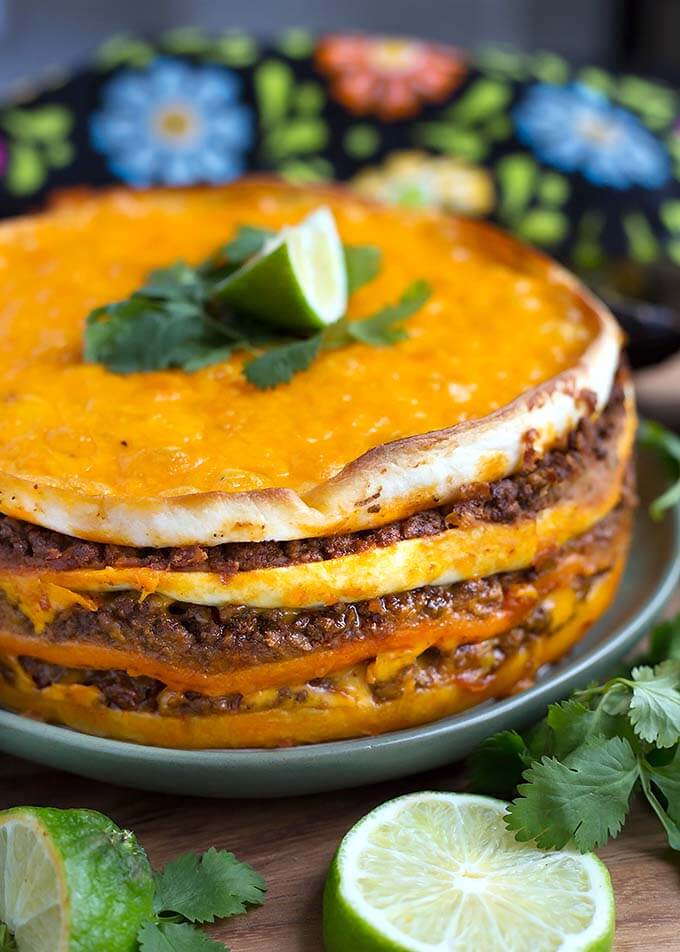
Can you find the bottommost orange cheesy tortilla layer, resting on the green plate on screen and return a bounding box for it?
[0,559,624,749]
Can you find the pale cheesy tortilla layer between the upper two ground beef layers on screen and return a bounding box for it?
[0,398,636,612]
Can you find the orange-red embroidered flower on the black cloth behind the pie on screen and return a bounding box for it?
[316,34,467,120]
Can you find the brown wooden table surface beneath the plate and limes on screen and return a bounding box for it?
[0,593,680,952]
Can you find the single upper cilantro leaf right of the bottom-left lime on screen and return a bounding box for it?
[154,849,266,922]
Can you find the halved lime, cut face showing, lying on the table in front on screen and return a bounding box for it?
[324,793,614,952]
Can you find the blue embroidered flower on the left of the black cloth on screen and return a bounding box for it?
[90,58,253,186]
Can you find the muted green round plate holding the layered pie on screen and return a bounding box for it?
[0,455,680,797]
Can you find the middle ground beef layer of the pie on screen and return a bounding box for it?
[0,503,630,674]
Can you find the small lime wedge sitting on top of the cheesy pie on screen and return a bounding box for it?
[214,206,347,333]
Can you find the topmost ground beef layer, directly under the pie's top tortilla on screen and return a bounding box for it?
[0,368,626,577]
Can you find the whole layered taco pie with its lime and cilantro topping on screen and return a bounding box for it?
[0,178,635,748]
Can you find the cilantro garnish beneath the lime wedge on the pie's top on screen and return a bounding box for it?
[84,225,430,389]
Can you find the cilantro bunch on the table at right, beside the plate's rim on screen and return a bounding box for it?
[471,615,680,852]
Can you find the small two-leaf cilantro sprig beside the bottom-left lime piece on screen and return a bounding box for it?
[138,849,266,952]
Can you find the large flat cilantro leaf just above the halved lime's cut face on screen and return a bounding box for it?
[506,737,640,852]
